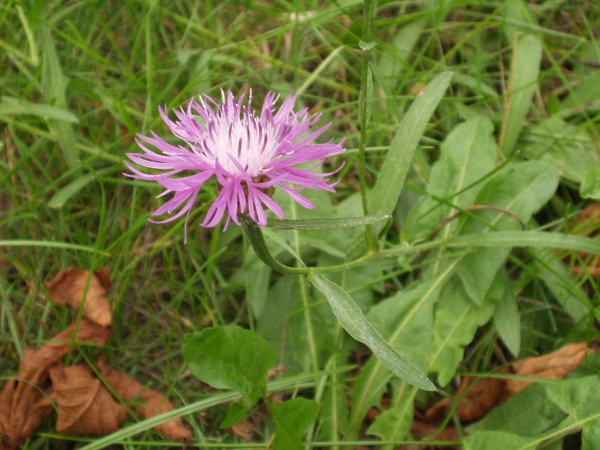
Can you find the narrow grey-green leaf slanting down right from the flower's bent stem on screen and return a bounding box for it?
[308,270,435,391]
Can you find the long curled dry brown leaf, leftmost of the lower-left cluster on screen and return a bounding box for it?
[10,319,110,439]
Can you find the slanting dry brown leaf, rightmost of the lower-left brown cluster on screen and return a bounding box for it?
[97,358,192,442]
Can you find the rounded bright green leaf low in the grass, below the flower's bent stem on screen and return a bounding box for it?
[181,327,276,406]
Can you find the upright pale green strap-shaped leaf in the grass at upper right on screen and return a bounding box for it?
[501,35,542,156]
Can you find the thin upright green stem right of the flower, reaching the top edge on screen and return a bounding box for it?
[358,0,377,253]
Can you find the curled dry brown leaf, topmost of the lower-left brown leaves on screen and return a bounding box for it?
[46,269,112,327]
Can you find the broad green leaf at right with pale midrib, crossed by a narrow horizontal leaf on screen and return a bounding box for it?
[456,161,558,304]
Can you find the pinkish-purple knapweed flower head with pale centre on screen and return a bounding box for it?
[125,91,344,241]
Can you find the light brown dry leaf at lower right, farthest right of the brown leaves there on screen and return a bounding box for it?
[506,342,587,396]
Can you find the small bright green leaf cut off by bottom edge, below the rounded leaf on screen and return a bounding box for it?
[269,397,319,450]
